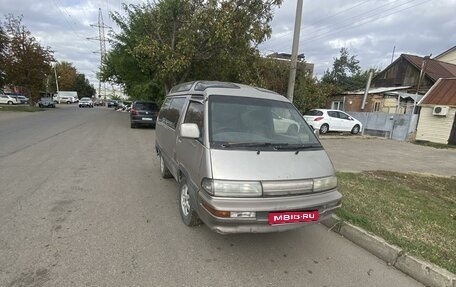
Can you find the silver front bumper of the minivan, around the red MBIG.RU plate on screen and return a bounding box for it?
[197,189,342,234]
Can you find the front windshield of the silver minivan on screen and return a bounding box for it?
[208,95,321,150]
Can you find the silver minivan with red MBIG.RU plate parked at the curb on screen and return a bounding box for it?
[155,81,342,234]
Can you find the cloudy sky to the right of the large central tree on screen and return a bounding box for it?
[260,0,456,75]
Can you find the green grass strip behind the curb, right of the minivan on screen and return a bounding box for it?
[337,171,456,273]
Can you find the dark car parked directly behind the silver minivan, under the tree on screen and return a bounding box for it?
[130,101,159,129]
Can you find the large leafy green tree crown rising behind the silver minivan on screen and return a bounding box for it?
[102,0,282,100]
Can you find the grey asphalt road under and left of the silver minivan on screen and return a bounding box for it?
[0,106,422,287]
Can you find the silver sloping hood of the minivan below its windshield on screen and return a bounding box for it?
[211,149,335,180]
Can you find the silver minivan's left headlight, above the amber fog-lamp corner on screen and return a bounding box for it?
[201,178,263,197]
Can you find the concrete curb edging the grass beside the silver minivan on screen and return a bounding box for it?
[321,215,456,287]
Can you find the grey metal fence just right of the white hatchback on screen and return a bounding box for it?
[349,112,418,141]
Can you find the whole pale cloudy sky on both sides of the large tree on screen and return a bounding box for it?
[0,0,456,88]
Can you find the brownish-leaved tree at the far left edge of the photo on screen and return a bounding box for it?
[3,14,53,104]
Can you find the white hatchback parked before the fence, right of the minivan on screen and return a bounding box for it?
[304,109,363,135]
